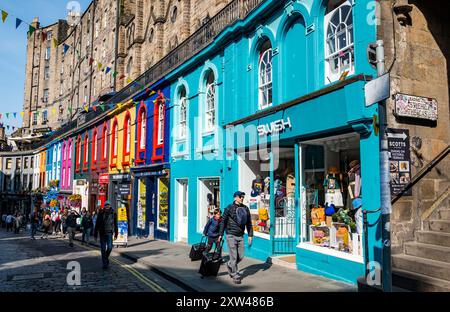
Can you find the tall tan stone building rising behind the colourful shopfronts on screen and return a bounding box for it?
[18,0,230,137]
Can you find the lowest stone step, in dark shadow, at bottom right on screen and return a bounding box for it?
[392,269,450,292]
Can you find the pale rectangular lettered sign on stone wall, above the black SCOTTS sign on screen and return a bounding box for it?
[394,93,438,121]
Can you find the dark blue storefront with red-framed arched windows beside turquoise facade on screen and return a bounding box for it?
[131,79,171,240]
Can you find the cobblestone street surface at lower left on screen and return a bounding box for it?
[0,229,183,292]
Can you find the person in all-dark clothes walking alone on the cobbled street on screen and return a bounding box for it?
[94,201,119,270]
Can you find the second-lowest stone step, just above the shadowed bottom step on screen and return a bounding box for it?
[392,254,450,281]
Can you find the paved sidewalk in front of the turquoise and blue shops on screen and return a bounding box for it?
[75,234,357,292]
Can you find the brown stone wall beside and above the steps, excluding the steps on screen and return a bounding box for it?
[379,0,450,253]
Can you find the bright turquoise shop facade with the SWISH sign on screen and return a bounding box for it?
[165,0,382,284]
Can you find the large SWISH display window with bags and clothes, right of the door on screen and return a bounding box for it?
[300,134,363,257]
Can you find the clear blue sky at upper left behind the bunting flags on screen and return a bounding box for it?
[0,0,91,134]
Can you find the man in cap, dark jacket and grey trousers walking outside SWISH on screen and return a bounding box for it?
[220,191,253,284]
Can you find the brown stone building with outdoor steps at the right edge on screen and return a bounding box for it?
[378,0,450,291]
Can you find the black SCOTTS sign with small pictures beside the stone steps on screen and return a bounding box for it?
[387,129,412,196]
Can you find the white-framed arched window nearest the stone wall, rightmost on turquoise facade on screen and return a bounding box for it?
[324,0,355,82]
